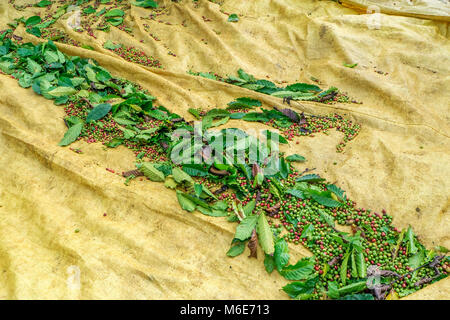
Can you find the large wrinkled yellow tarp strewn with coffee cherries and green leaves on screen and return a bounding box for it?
[0,0,450,299]
